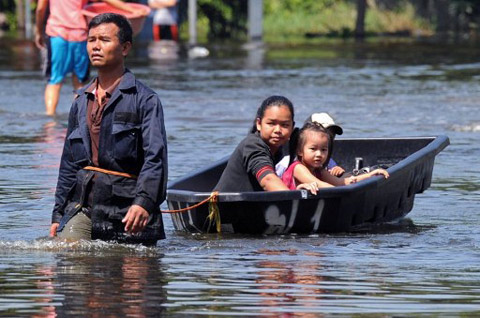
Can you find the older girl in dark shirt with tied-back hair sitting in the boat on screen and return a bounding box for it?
[215,96,316,192]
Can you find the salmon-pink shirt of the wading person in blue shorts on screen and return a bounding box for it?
[45,0,88,42]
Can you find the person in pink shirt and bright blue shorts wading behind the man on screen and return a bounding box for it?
[35,0,146,116]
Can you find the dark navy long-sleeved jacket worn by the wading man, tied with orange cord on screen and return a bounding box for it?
[52,70,167,243]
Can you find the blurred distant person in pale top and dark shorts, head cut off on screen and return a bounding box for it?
[148,0,178,41]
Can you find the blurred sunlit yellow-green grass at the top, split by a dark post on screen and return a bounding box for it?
[264,0,430,41]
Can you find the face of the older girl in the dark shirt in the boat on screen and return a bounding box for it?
[257,105,293,153]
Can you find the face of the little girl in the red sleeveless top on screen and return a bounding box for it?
[297,130,328,170]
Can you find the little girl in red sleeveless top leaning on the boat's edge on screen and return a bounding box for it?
[282,122,389,194]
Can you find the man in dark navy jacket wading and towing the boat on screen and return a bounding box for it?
[50,13,167,245]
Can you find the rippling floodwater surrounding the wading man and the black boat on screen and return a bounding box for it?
[0,40,480,318]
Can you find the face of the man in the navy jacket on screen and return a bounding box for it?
[87,23,132,68]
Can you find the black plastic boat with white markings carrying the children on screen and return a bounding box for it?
[167,136,450,234]
